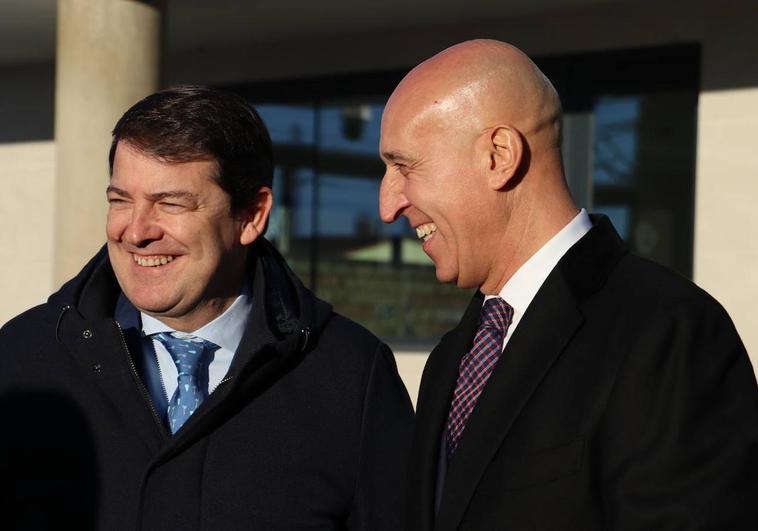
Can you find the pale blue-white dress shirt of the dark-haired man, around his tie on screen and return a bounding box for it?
[140,289,253,400]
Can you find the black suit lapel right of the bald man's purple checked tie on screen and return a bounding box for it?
[435,270,583,531]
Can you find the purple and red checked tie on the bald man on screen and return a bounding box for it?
[445,297,513,462]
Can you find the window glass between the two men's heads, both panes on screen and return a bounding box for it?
[256,96,471,348]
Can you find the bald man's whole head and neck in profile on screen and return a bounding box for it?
[379,40,577,293]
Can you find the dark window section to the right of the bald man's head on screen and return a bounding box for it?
[538,45,699,276]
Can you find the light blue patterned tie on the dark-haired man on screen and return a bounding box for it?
[152,332,219,433]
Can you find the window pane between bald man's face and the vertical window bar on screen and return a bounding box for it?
[316,99,470,345]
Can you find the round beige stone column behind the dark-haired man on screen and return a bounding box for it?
[53,0,164,287]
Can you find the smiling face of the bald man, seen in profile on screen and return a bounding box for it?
[379,93,496,288]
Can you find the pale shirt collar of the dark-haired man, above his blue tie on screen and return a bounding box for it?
[140,285,253,352]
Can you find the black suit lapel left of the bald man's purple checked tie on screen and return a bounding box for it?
[407,293,484,531]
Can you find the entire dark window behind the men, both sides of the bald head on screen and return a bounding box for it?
[237,46,699,348]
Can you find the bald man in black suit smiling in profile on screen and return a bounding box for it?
[380,41,758,531]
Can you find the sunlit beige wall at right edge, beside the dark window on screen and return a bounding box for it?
[694,86,758,368]
